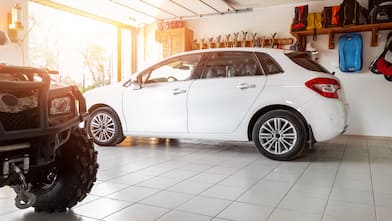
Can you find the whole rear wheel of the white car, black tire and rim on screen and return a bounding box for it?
[252,110,306,161]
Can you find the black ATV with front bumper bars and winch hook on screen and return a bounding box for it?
[0,64,98,212]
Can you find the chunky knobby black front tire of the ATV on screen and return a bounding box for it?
[31,128,98,212]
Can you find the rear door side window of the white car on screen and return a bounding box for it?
[203,51,263,79]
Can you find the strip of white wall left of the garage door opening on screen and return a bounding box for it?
[0,0,28,65]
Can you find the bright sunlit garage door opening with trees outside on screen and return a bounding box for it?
[28,2,132,91]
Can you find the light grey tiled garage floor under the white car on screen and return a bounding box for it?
[0,136,392,221]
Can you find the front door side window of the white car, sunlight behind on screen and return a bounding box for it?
[143,54,202,84]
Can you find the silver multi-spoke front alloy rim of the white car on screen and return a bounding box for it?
[90,112,116,143]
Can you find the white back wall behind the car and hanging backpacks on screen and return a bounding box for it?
[186,0,392,137]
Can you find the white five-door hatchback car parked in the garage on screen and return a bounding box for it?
[85,48,348,160]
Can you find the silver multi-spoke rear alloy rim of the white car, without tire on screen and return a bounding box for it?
[259,117,297,155]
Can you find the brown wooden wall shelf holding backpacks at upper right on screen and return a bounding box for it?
[291,22,392,49]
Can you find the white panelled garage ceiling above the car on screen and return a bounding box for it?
[31,0,322,27]
